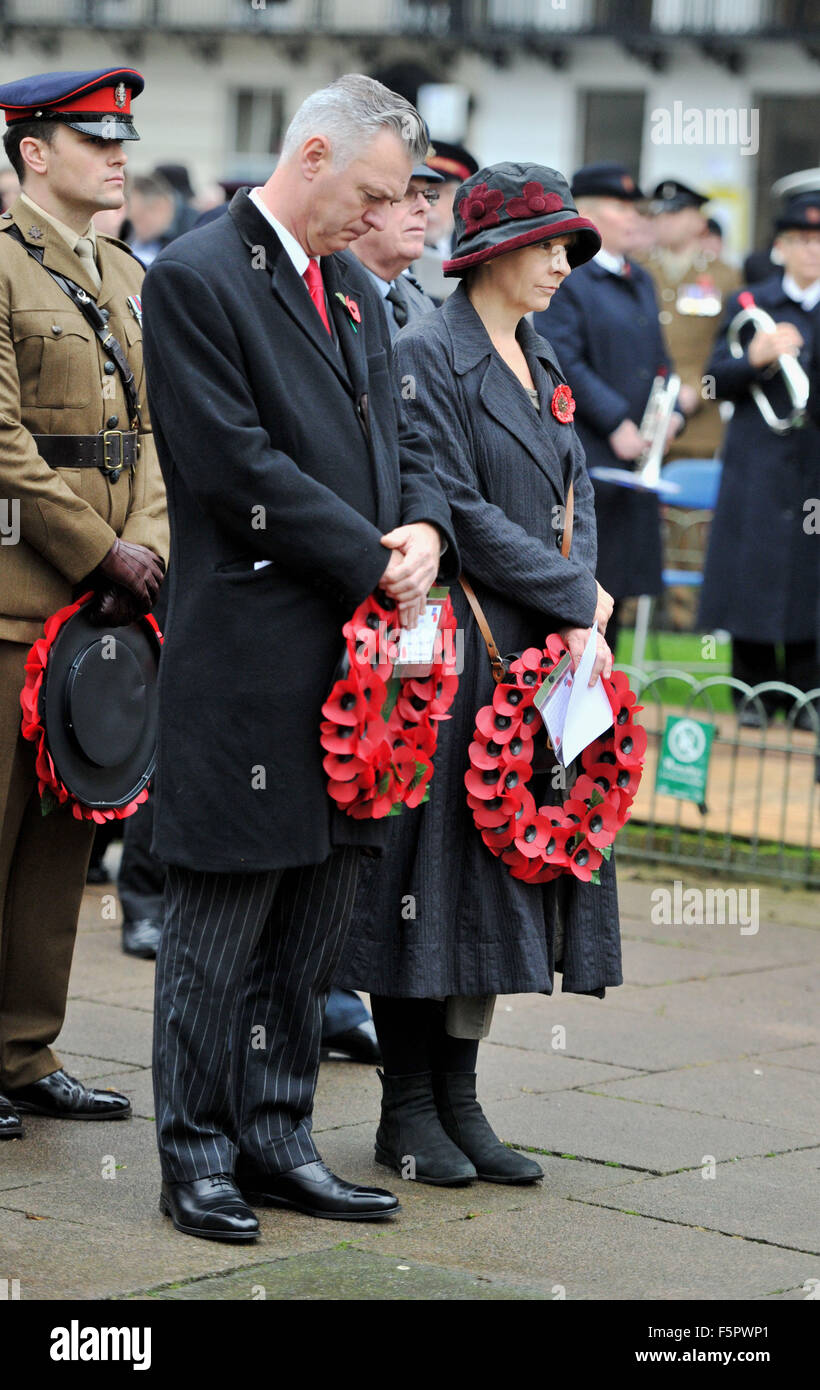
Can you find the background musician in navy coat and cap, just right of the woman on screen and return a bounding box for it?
[534,163,684,652]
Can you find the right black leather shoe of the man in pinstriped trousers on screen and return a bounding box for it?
[236,1158,400,1220]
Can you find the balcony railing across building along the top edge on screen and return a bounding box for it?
[0,0,820,42]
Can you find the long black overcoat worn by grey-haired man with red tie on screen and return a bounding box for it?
[145,190,457,872]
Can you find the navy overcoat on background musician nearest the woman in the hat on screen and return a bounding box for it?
[534,260,670,599]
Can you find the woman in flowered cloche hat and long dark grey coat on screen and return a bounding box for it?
[336,164,623,1184]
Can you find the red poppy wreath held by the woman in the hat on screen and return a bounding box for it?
[464,632,646,883]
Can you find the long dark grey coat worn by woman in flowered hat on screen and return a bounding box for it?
[338,286,621,998]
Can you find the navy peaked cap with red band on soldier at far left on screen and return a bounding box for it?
[0,68,145,140]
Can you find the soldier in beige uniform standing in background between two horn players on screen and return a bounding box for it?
[643,179,741,460]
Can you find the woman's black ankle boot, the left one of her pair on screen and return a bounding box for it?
[375,1072,475,1187]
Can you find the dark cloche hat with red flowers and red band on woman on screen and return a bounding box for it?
[442,164,600,275]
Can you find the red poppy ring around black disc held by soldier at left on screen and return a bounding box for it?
[19,589,163,826]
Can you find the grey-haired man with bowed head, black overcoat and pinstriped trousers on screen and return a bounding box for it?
[145,75,457,1240]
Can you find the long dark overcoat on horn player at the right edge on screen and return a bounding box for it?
[698,275,820,642]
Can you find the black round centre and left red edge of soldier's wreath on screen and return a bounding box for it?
[21,595,161,815]
